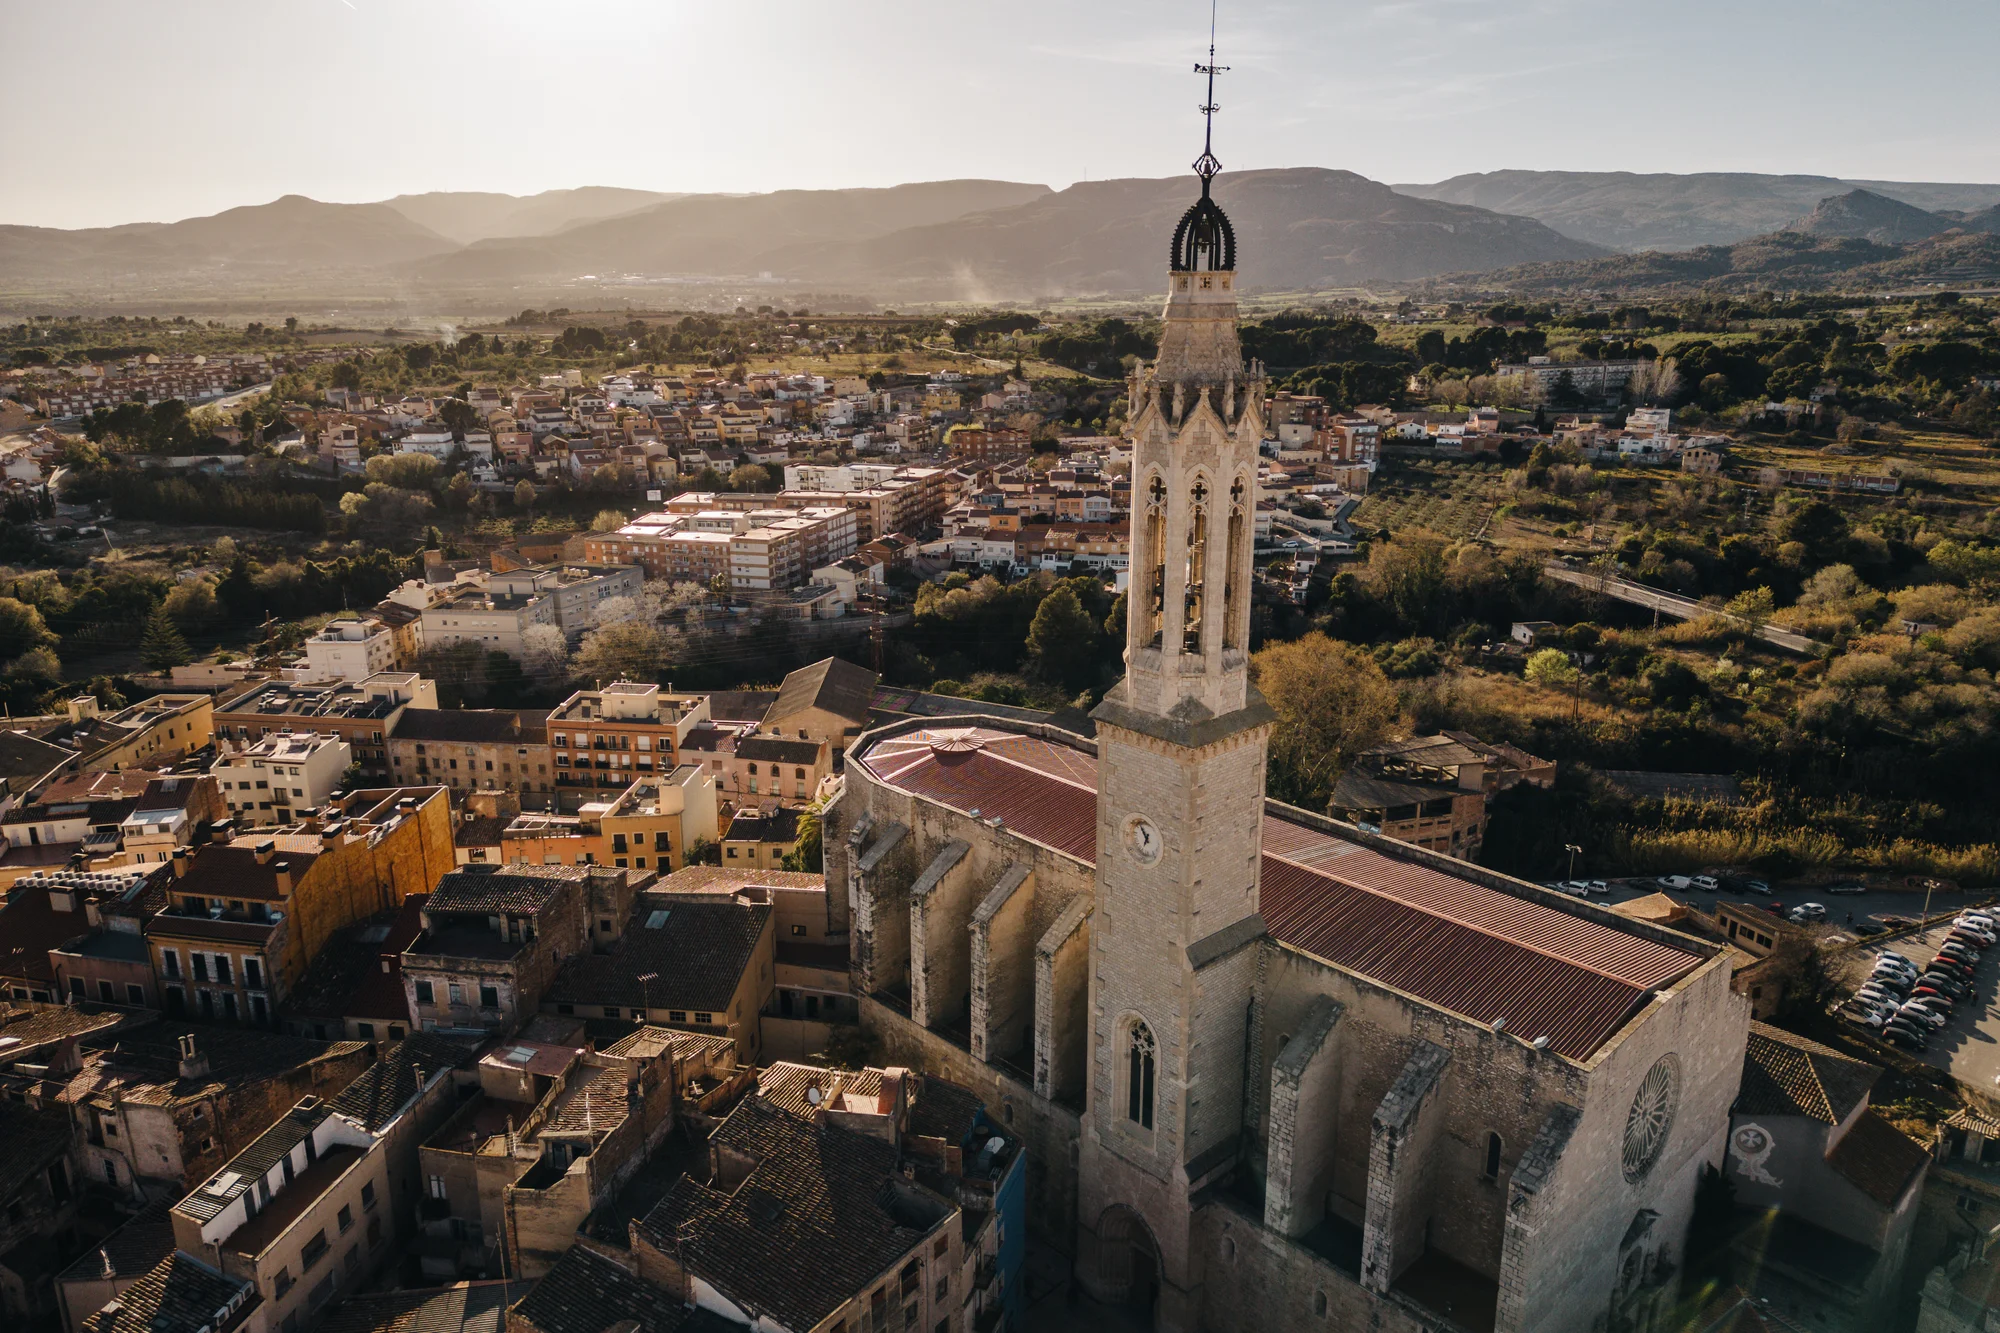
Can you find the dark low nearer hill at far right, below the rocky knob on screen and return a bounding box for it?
[1466,230,2000,294]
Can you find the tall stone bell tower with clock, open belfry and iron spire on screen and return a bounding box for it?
[1076,33,1272,1329]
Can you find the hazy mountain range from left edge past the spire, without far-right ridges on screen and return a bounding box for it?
[0,168,1602,300]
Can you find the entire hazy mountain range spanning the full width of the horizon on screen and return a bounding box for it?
[11,166,2000,310]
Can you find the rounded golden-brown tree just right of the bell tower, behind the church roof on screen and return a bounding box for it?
[1250,630,1398,811]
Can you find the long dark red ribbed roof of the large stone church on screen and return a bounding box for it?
[856,727,1702,1059]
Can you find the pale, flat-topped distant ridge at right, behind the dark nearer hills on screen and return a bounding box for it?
[1396,170,2000,250]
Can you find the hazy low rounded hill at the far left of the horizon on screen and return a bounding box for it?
[0,194,456,286]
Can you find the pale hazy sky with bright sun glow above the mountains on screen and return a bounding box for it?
[15,0,2000,226]
